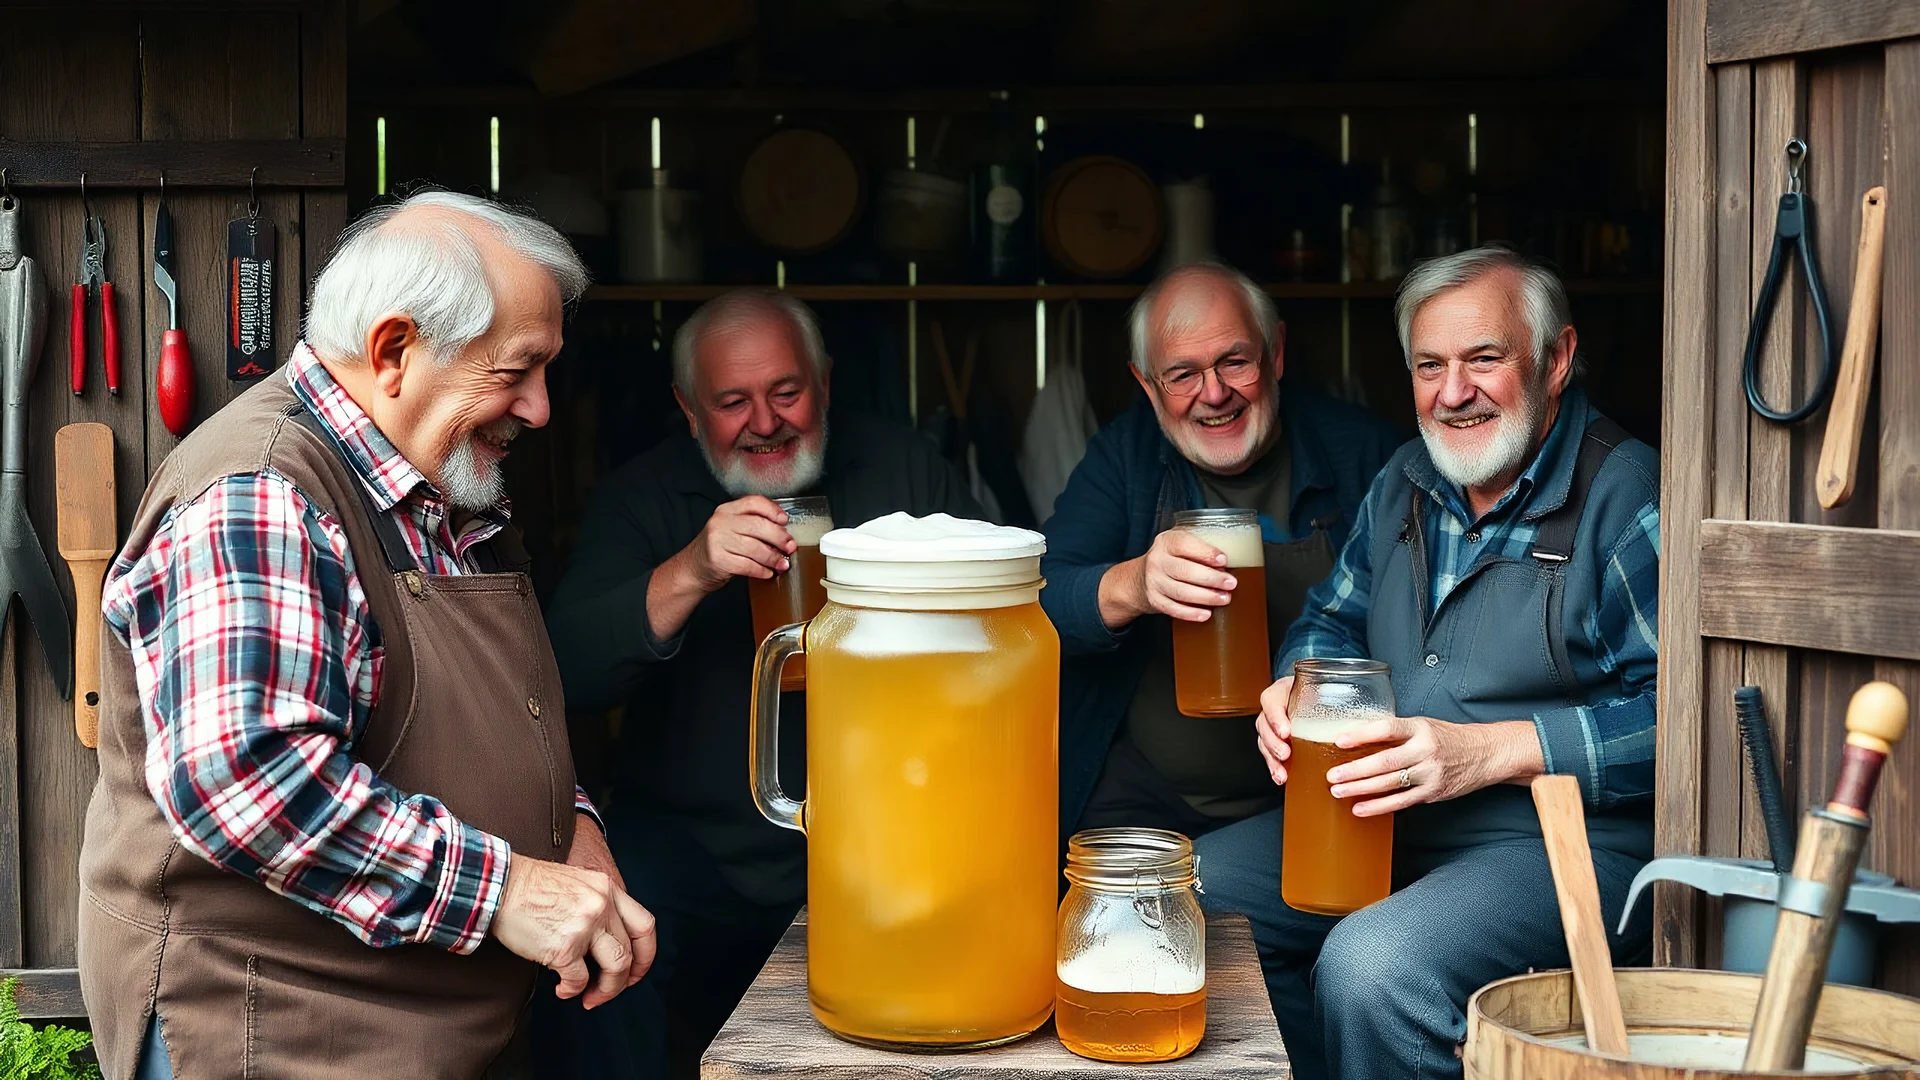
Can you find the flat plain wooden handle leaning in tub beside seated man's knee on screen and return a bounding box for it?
[1532,776,1628,1057]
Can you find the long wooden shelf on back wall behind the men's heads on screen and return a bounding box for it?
[586,277,1661,304]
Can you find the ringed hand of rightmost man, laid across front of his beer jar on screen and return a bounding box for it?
[1327,717,1505,817]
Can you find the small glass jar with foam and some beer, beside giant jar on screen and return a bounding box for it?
[1054,828,1206,1063]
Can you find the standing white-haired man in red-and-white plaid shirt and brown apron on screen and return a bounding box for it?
[79,192,653,1080]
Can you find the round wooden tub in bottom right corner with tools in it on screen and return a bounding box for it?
[1463,969,1920,1080]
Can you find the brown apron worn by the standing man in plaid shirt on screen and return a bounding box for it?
[79,373,574,1080]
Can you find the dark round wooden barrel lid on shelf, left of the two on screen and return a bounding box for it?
[739,127,862,254]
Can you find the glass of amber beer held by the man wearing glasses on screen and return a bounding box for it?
[1173,509,1273,717]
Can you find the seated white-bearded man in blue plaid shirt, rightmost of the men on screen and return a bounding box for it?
[1196,246,1661,1080]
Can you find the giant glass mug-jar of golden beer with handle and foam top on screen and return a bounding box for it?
[751,513,1060,1049]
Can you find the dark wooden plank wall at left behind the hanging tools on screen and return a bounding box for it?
[0,2,346,969]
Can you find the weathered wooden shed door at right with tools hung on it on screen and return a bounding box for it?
[1655,0,1920,994]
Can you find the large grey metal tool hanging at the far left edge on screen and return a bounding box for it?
[0,178,73,700]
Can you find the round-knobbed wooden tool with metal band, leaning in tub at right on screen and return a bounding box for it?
[1743,682,1907,1072]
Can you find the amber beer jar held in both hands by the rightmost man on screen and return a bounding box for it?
[1281,659,1394,915]
